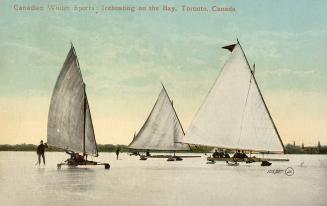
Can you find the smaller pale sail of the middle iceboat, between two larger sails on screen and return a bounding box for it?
[129,84,190,151]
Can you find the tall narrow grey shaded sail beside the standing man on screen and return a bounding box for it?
[47,46,98,156]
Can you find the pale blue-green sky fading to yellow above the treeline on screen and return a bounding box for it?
[0,0,327,145]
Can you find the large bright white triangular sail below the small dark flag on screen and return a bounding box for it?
[183,43,284,152]
